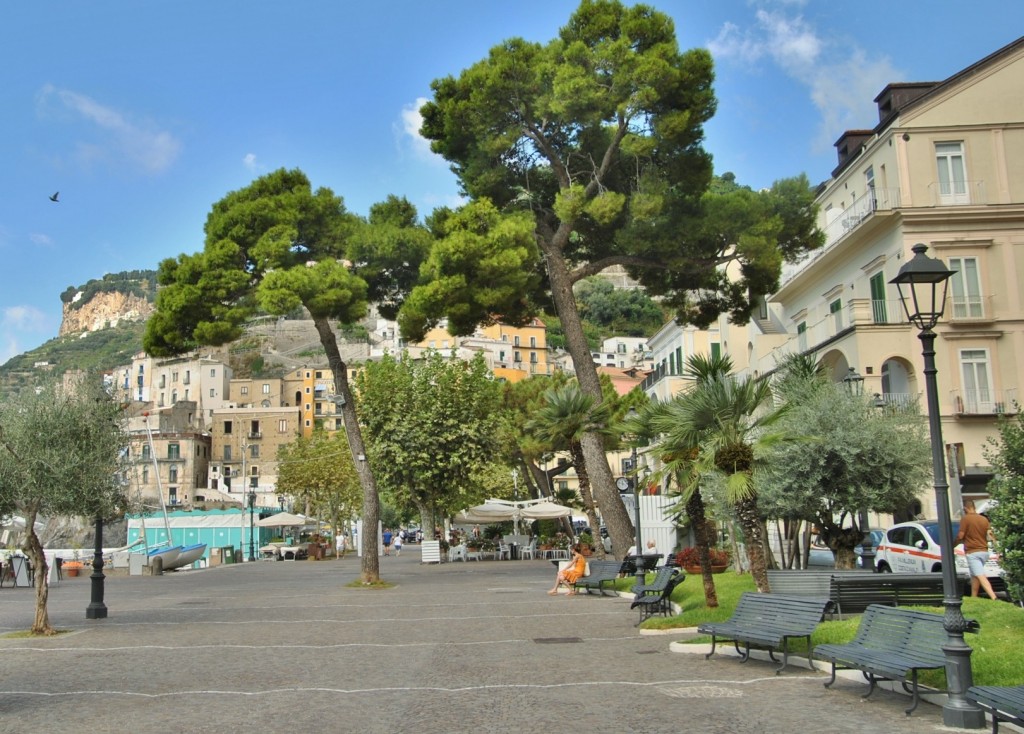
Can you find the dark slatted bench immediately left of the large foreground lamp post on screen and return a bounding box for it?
[814,604,976,716]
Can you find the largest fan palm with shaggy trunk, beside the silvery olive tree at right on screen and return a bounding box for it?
[666,364,786,592]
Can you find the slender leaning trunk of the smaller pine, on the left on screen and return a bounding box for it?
[313,318,381,584]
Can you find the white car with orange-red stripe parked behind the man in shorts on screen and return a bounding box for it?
[874,520,1004,588]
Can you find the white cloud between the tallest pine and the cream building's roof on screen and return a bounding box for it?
[708,2,903,152]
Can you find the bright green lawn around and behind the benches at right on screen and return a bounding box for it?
[634,571,1024,688]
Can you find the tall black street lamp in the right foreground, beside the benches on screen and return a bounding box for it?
[889,244,985,729]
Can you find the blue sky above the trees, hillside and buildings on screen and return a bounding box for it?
[0,0,1024,363]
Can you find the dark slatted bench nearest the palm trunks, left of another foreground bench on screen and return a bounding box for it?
[697,592,829,675]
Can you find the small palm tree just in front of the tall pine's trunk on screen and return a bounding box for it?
[526,381,610,558]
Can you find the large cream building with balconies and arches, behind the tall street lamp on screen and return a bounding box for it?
[741,39,1024,517]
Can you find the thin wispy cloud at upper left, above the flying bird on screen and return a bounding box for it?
[37,84,181,173]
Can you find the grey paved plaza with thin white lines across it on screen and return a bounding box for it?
[0,545,983,734]
